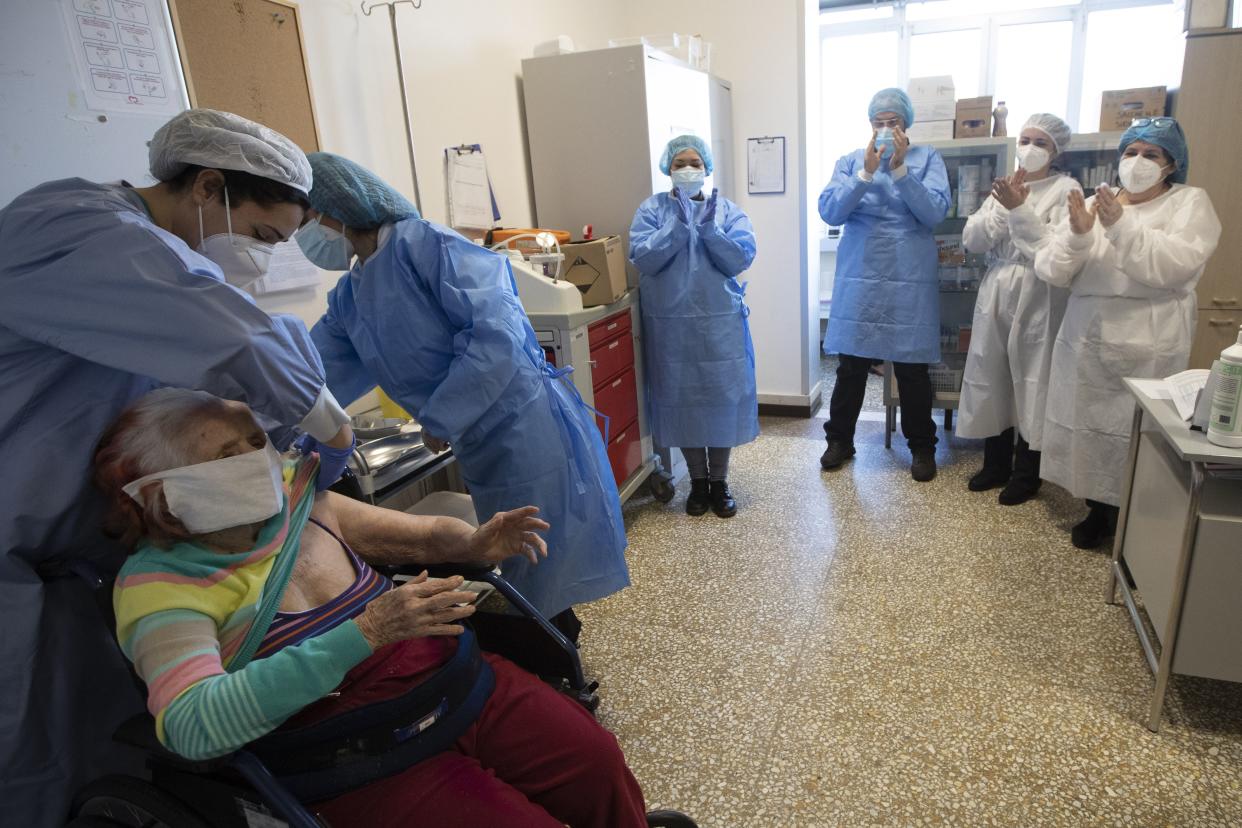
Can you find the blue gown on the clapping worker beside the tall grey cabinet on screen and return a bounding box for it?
[630,192,759,448]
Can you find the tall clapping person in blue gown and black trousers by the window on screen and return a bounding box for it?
[820,89,949,482]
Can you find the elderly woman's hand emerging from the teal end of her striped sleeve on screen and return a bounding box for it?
[355,572,476,650]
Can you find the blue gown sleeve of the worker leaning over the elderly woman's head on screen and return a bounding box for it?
[0,215,324,426]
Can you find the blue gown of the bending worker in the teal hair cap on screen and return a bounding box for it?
[311,218,630,614]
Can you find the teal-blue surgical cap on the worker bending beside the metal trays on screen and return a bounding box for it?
[307,153,419,230]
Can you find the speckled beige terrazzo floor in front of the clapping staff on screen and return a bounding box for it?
[580,407,1242,828]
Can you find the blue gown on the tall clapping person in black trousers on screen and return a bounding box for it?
[820,145,949,362]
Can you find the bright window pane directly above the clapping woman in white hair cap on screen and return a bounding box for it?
[988,20,1078,135]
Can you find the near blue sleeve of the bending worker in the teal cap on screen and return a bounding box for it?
[402,231,527,443]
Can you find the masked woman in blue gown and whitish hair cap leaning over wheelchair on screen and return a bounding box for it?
[0,109,353,826]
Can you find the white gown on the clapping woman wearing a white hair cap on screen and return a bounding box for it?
[956,175,1082,451]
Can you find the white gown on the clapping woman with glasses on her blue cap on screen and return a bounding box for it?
[1035,184,1221,505]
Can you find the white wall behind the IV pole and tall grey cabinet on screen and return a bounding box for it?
[260,0,820,403]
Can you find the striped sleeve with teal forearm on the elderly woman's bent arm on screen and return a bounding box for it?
[129,610,371,760]
